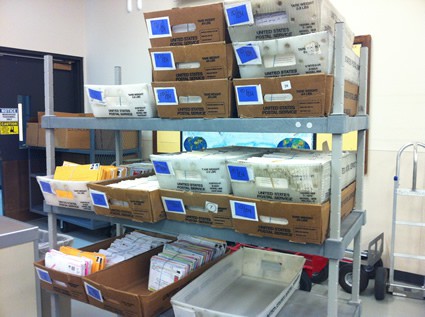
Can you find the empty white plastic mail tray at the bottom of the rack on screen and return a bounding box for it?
[171,248,305,317]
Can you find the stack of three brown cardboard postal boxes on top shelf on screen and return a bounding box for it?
[144,3,237,118]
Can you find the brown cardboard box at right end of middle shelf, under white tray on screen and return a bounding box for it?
[230,183,356,244]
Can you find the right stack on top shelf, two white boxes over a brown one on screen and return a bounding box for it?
[224,0,359,117]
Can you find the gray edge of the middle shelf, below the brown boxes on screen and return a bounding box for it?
[45,202,365,260]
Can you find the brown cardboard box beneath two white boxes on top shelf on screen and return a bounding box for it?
[233,74,359,118]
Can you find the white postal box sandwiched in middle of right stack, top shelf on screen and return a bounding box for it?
[232,32,360,85]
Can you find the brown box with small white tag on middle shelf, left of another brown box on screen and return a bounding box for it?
[160,189,233,228]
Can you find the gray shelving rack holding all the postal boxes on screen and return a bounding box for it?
[42,23,368,317]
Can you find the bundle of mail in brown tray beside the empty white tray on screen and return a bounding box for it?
[148,234,226,291]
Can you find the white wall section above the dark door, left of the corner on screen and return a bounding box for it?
[0,0,86,56]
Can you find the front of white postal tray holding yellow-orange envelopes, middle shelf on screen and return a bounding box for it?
[37,175,93,211]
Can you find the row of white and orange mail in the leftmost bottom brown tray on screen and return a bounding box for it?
[45,231,170,276]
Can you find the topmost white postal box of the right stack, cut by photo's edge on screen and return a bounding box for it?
[224,0,354,46]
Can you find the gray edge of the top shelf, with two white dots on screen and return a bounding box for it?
[42,115,368,134]
